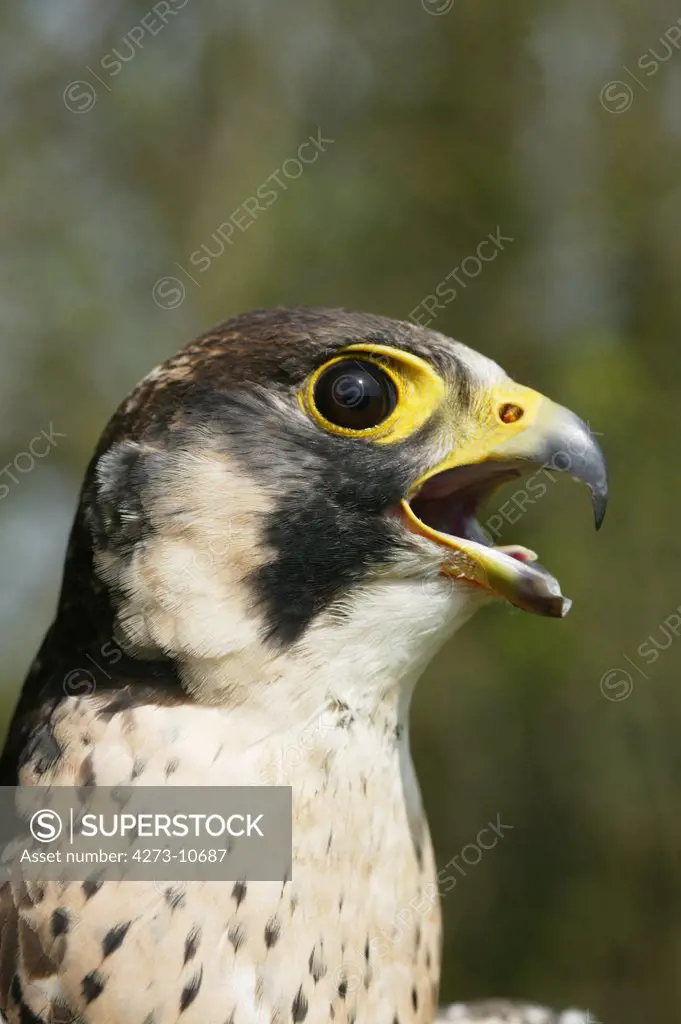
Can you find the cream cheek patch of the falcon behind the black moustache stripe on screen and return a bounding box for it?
[95,452,270,659]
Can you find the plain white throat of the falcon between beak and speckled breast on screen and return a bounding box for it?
[176,579,482,726]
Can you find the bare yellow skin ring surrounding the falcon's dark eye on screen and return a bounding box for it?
[298,343,446,444]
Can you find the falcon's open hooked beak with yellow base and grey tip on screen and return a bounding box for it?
[401,381,607,617]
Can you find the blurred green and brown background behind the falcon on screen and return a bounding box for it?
[0,0,681,1024]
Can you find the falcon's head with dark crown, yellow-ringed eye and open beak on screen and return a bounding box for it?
[45,308,607,702]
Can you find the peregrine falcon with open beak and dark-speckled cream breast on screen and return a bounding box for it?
[0,308,607,1024]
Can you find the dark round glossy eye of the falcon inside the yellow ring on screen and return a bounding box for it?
[314,359,397,430]
